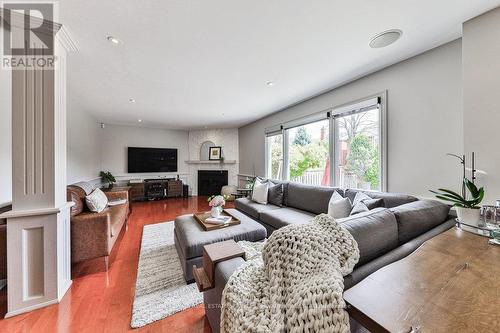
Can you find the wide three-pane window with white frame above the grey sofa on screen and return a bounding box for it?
[266,94,387,190]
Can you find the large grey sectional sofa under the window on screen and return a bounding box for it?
[204,182,455,332]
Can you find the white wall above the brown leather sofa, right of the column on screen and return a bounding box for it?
[66,107,102,184]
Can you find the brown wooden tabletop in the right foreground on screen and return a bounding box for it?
[344,228,500,332]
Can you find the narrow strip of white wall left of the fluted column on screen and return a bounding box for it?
[0,63,12,207]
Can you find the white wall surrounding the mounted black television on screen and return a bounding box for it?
[100,124,189,179]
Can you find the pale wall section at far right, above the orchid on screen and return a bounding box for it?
[463,8,500,204]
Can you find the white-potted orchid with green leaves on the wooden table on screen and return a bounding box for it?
[431,178,484,225]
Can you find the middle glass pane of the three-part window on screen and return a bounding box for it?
[287,119,330,186]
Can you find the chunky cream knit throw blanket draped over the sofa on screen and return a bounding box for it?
[221,214,359,333]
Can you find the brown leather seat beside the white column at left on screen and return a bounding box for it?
[67,185,130,270]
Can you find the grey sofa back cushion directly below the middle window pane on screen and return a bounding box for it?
[286,182,335,214]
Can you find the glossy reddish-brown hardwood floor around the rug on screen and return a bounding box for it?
[0,197,232,333]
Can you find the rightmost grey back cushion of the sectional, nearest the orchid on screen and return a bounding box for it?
[391,200,450,244]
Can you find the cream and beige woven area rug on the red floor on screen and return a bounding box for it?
[130,222,203,328]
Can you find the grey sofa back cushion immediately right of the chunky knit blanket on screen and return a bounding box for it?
[339,208,398,266]
